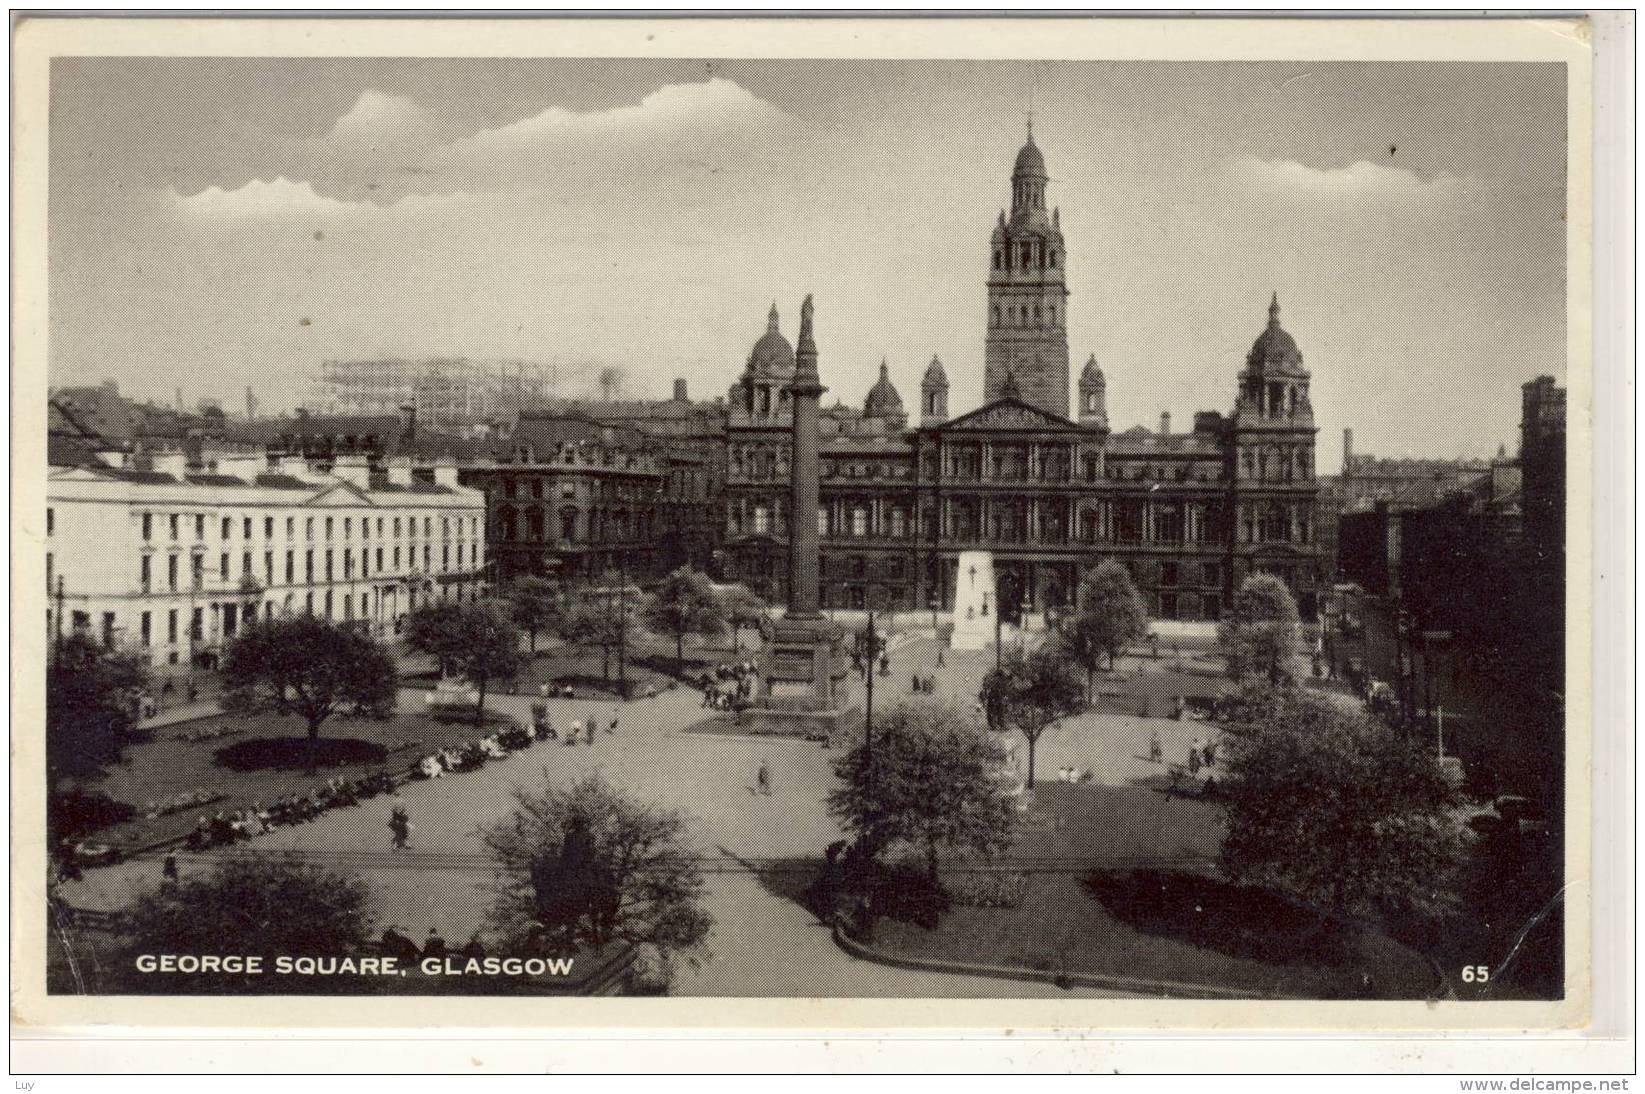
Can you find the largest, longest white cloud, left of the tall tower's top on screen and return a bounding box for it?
[429,77,790,169]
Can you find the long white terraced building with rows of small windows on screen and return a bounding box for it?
[46,452,485,674]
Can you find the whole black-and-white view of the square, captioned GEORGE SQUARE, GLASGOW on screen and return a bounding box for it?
[13,12,1591,1046]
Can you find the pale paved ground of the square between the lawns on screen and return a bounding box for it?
[69,638,1202,997]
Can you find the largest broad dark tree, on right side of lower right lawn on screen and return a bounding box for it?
[1219,684,1464,915]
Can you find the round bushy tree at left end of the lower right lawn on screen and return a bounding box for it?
[827,702,1013,882]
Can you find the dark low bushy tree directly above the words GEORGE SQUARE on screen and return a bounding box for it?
[125,857,370,990]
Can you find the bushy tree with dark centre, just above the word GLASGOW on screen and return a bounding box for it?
[482,772,714,956]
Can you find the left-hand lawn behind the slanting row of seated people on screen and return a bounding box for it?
[72,693,513,849]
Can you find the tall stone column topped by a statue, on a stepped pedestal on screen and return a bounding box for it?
[739,296,847,734]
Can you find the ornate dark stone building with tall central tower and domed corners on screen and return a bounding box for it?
[717,132,1318,620]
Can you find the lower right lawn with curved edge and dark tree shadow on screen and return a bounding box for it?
[873,785,1433,999]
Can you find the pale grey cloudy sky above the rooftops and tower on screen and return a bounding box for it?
[48,58,1564,472]
